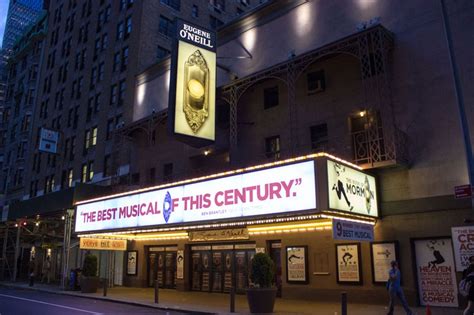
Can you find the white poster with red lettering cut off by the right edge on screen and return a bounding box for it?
[451,226,474,272]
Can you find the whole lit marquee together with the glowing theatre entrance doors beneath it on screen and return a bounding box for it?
[75,153,378,295]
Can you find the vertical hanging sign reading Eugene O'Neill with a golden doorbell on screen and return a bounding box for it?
[168,20,216,146]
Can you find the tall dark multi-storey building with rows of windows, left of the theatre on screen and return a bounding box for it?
[2,0,259,282]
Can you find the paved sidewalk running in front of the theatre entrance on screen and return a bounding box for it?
[0,282,461,315]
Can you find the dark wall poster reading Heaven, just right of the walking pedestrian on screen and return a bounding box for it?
[413,238,458,307]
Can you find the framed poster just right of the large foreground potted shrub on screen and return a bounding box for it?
[286,246,309,284]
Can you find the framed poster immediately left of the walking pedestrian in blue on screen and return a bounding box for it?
[370,241,399,284]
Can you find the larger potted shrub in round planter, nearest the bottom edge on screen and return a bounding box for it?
[247,253,277,313]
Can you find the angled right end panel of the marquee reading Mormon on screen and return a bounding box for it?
[327,160,378,217]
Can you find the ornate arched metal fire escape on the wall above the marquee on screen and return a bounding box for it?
[222,25,408,168]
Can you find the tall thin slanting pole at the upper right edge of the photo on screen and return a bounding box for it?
[440,0,474,209]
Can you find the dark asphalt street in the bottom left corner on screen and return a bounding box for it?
[0,287,191,315]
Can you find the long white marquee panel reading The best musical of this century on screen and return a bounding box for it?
[76,161,316,232]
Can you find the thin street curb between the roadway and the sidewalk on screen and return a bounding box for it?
[0,282,215,315]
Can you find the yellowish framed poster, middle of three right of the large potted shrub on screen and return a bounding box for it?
[336,243,362,284]
